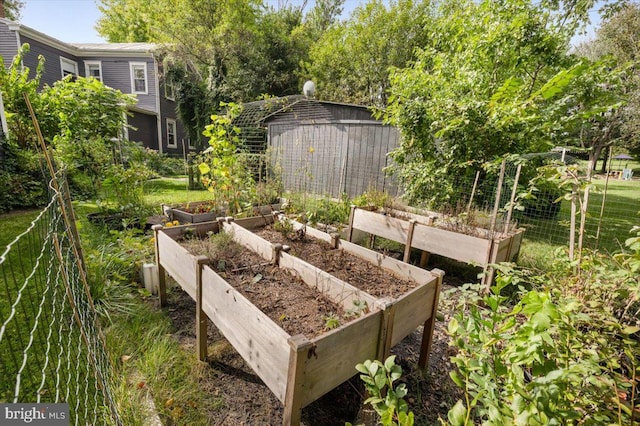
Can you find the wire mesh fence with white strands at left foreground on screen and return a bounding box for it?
[0,174,120,425]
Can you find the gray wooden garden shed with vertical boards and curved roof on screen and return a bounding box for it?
[235,96,399,198]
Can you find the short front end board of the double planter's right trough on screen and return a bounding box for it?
[391,282,438,346]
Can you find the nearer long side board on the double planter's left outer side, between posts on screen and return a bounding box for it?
[202,266,290,402]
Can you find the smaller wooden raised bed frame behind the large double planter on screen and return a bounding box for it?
[346,206,525,285]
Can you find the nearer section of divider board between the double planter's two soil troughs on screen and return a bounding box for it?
[280,252,377,309]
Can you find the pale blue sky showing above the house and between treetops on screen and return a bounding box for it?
[21,0,600,45]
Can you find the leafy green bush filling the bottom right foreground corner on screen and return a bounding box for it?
[448,235,640,425]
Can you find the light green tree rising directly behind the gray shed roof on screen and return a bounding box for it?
[304,0,432,106]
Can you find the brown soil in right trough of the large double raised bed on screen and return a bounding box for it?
[253,225,416,298]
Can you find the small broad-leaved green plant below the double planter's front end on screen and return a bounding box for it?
[347,355,414,426]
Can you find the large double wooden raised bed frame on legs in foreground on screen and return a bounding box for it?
[154,215,444,425]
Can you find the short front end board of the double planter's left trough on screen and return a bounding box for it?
[302,311,382,407]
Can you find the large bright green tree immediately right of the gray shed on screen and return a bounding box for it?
[385,0,604,204]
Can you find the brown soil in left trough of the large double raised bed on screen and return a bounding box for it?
[183,234,344,338]
